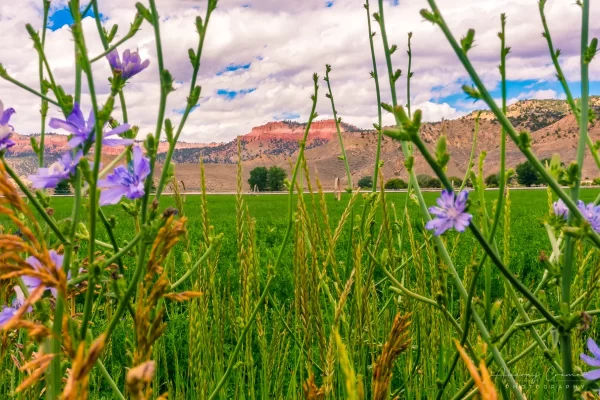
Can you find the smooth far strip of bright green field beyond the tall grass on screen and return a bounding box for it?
[52,189,600,290]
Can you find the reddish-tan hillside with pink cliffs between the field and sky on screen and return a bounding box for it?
[9,97,600,192]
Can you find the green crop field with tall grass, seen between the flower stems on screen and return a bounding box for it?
[31,189,598,399]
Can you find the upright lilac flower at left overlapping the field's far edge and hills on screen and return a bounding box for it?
[98,146,150,206]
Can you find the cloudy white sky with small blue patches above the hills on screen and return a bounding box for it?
[0,0,600,143]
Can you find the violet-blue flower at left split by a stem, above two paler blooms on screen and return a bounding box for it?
[49,103,133,149]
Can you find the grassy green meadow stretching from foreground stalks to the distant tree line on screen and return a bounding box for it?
[17,189,598,399]
